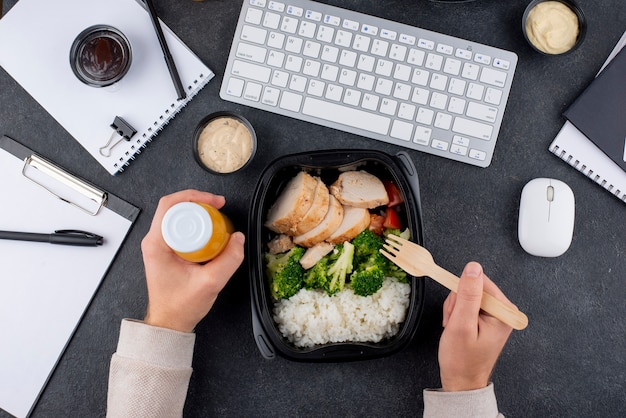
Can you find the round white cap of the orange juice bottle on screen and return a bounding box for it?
[161,202,213,253]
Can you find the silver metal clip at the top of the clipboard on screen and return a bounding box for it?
[22,154,108,216]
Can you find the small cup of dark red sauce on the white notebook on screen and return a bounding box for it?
[70,25,132,87]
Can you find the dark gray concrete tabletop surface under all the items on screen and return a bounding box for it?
[0,0,626,417]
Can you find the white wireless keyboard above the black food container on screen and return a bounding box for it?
[220,0,517,167]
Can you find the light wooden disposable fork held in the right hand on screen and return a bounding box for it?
[380,234,528,330]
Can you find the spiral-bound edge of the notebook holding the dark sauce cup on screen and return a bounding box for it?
[113,74,212,173]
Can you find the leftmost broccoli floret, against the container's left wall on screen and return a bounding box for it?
[265,246,305,300]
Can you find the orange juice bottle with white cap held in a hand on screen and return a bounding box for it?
[161,202,234,263]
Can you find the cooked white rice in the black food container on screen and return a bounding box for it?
[274,278,411,347]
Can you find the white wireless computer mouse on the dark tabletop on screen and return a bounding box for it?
[517,178,575,257]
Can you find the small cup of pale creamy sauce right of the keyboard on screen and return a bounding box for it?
[522,0,587,55]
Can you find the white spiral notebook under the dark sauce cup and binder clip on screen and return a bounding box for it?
[0,0,214,174]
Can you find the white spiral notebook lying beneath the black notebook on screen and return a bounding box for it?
[548,32,626,203]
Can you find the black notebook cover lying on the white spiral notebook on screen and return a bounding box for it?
[564,48,626,171]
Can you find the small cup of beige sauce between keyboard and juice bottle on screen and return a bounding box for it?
[193,112,257,174]
